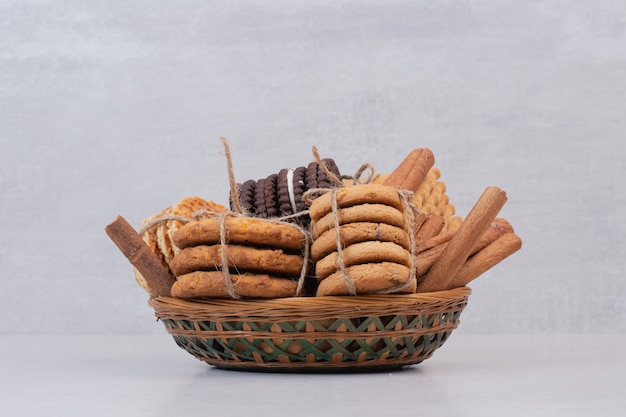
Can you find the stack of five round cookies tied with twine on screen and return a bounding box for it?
[309,183,415,296]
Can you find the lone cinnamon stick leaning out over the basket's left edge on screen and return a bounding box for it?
[104,216,176,297]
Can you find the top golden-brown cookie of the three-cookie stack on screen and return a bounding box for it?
[173,217,306,252]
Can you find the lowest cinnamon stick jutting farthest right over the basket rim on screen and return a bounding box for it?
[448,232,522,289]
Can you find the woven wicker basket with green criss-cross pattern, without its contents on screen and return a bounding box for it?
[149,287,471,372]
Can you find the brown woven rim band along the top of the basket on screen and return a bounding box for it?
[148,287,471,321]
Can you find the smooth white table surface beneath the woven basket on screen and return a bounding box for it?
[0,332,626,417]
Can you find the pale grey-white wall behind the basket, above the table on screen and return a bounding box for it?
[0,0,626,334]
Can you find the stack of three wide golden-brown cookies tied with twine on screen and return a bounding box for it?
[169,213,308,298]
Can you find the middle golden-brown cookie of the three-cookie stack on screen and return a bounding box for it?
[170,245,304,277]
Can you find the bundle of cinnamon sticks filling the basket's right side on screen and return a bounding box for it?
[384,148,522,292]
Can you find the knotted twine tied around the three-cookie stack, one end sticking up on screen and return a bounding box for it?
[139,137,312,300]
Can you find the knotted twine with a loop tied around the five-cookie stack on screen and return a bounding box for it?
[302,147,417,295]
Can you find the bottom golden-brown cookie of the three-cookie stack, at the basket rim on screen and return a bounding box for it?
[172,271,298,298]
